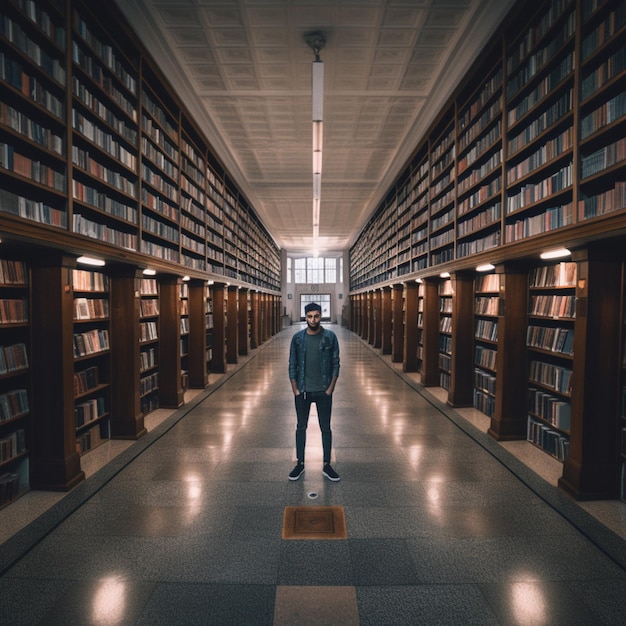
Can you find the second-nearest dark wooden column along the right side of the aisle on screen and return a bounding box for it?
[488,264,528,441]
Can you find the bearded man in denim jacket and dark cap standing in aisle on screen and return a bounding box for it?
[289,302,340,482]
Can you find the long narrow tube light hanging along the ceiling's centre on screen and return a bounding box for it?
[304,32,326,255]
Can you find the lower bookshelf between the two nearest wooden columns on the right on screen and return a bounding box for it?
[526,262,576,461]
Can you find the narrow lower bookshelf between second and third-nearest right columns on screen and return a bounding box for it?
[473,273,500,417]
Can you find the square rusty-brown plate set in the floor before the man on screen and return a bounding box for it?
[283,506,348,539]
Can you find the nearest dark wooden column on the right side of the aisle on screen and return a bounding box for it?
[559,242,623,500]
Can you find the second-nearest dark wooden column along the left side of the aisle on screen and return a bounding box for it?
[109,265,147,439]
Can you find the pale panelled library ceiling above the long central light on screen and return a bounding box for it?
[116,0,513,255]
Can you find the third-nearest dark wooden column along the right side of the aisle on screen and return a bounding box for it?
[448,272,474,407]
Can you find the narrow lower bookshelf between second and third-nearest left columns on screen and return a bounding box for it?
[139,278,160,416]
